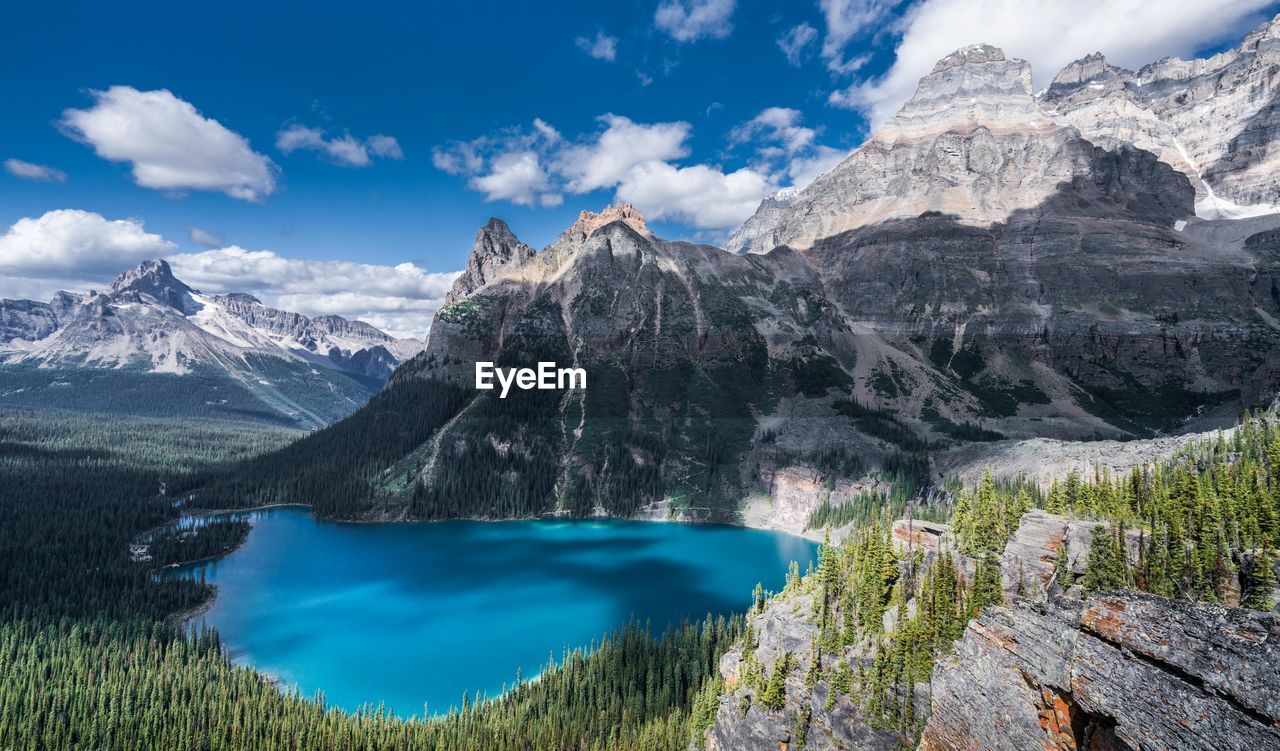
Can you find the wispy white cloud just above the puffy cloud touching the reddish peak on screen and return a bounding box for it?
[554,114,690,193]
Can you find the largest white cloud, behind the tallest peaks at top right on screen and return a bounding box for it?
[823,0,1270,125]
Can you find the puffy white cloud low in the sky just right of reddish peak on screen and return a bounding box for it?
[617,161,776,229]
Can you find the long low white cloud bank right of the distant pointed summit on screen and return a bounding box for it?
[169,246,460,338]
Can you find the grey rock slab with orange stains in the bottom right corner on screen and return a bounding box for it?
[920,592,1280,751]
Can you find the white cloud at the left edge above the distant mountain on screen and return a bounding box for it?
[0,209,175,279]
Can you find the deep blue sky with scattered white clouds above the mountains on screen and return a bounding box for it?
[0,0,1275,335]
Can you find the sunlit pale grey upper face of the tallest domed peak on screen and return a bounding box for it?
[730,45,1176,252]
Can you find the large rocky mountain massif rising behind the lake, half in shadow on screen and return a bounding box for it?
[212,20,1280,523]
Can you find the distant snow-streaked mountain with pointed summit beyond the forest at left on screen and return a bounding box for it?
[0,261,420,427]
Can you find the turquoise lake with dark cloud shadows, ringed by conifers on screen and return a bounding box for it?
[180,509,817,716]
